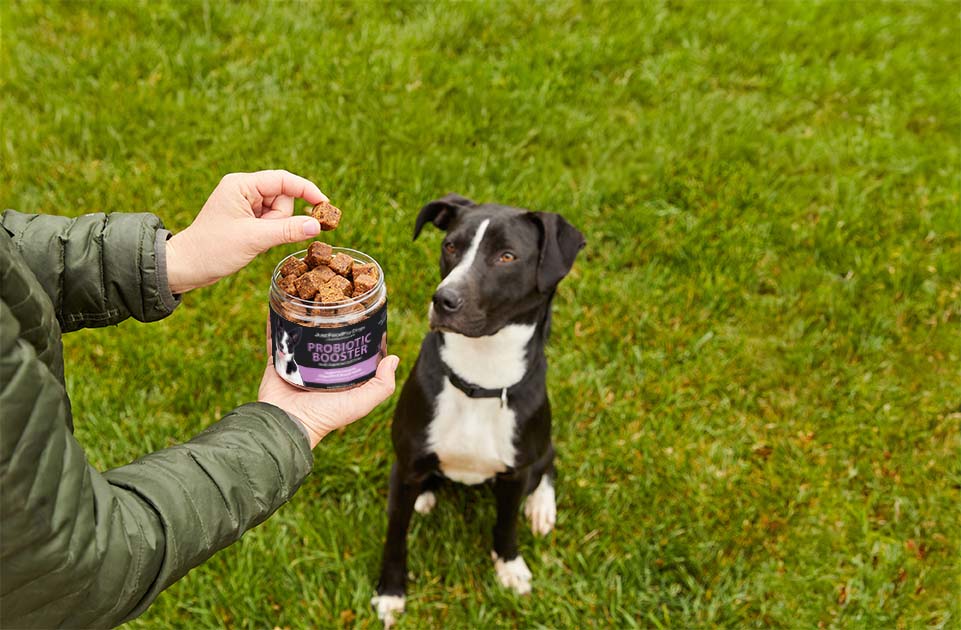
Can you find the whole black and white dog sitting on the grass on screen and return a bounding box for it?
[371,195,584,626]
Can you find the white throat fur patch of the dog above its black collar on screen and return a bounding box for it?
[440,324,536,389]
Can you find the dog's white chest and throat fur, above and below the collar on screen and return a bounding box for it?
[427,324,535,484]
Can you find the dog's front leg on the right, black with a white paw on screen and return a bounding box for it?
[491,475,531,595]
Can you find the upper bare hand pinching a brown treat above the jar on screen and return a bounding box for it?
[167,171,328,294]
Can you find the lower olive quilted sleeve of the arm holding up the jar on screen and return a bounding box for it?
[0,302,312,628]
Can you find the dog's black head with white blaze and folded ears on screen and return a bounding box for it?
[414,194,584,337]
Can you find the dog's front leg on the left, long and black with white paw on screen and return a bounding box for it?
[370,462,421,628]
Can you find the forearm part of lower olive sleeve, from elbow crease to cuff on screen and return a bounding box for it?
[104,403,313,619]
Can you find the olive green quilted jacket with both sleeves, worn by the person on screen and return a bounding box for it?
[0,210,313,628]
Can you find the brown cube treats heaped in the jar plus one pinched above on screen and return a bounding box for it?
[277,202,377,304]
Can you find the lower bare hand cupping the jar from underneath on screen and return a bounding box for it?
[257,326,400,449]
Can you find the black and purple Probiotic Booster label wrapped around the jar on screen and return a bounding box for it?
[270,302,387,389]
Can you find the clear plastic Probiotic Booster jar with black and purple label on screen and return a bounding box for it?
[270,247,387,391]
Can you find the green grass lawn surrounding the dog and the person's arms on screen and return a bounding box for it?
[0,0,961,629]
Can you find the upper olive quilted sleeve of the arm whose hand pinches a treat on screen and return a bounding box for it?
[2,210,180,332]
